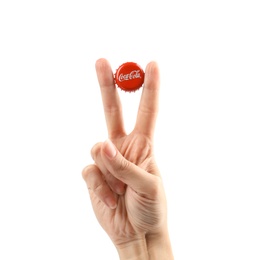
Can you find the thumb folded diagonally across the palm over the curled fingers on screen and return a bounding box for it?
[101,139,158,197]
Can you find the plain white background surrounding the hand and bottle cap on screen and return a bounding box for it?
[0,0,260,260]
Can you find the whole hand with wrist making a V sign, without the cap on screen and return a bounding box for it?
[82,59,173,260]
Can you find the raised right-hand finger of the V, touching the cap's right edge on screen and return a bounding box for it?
[135,61,160,137]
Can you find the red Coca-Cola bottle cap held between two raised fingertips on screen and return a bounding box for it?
[115,62,144,92]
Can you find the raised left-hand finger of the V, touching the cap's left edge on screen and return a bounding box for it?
[96,59,125,139]
